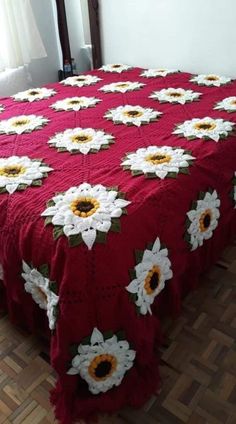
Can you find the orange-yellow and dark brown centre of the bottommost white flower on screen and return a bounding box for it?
[88,354,117,381]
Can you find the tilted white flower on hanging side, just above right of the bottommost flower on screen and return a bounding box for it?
[126,237,173,315]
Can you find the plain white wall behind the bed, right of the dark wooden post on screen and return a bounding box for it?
[100,0,236,77]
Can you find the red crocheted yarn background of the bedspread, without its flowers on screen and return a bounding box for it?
[0,68,236,424]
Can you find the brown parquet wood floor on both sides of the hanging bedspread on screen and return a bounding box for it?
[0,244,236,424]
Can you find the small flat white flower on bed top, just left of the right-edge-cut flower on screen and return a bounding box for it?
[149,88,201,105]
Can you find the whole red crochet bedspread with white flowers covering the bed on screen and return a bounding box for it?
[0,67,236,424]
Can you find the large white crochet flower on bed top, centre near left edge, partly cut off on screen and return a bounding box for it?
[0,156,52,194]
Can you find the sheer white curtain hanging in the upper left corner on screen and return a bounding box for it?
[0,0,47,70]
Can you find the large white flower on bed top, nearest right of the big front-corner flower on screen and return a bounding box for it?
[122,146,195,179]
